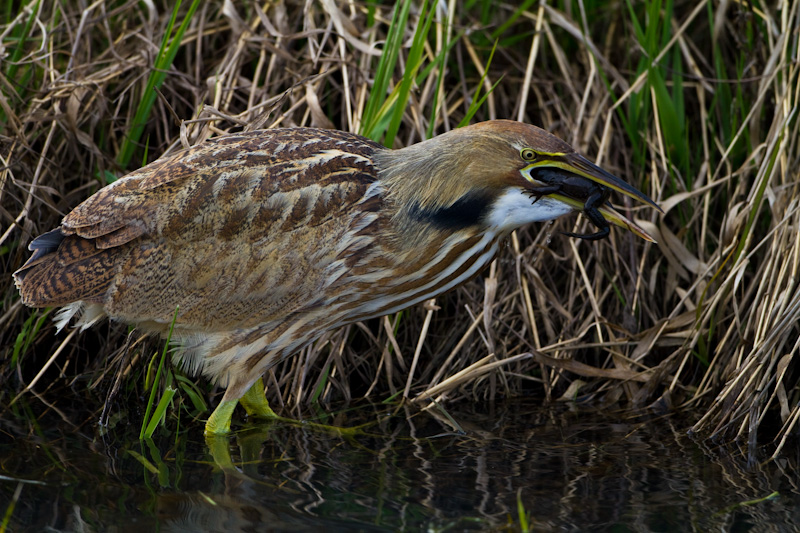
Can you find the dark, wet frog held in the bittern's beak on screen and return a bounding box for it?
[528,168,611,241]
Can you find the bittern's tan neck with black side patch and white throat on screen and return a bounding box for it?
[373,134,571,238]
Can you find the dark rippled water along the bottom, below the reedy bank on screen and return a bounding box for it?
[0,399,800,533]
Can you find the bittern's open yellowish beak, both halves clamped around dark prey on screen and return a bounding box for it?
[532,152,664,242]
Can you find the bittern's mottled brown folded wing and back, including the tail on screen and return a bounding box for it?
[17,129,381,326]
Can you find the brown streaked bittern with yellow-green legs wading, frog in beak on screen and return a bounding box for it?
[14,120,660,435]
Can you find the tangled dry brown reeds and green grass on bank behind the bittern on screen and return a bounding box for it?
[0,0,800,453]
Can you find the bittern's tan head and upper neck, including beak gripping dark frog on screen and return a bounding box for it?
[375,120,661,241]
